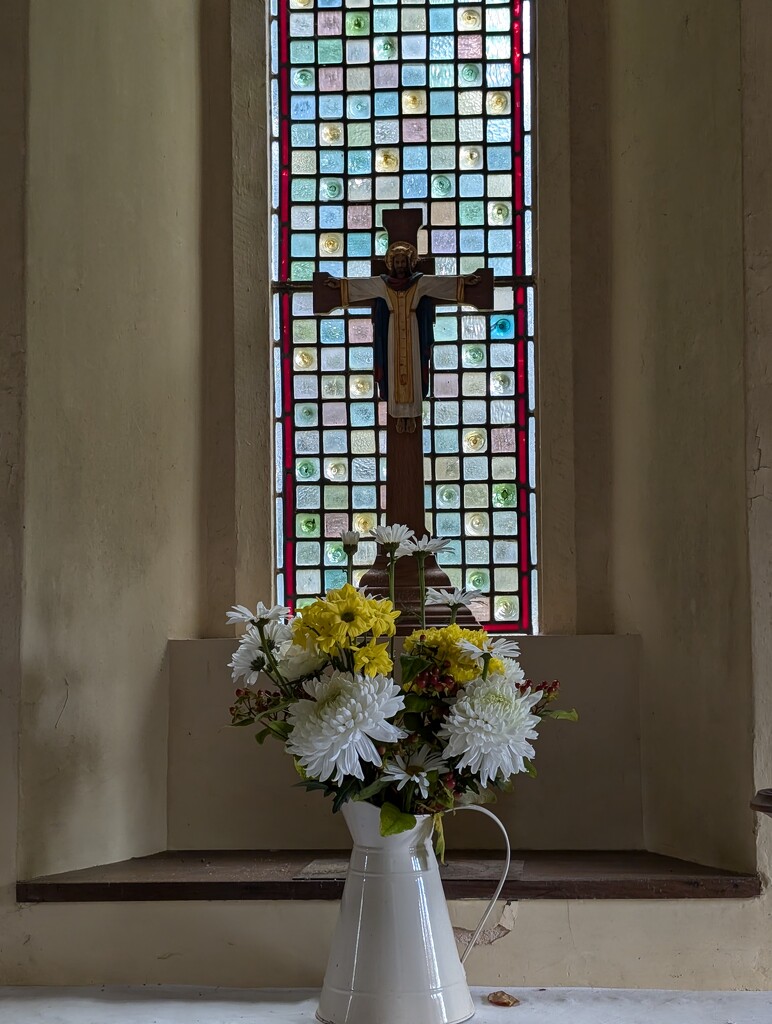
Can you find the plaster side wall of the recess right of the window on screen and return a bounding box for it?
[608,0,753,868]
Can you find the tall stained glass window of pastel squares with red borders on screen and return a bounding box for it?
[270,0,538,632]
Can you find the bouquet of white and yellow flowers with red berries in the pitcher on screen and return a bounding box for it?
[228,526,576,856]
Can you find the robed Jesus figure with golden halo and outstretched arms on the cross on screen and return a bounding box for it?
[325,242,479,433]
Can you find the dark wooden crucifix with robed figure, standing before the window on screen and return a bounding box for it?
[313,209,494,632]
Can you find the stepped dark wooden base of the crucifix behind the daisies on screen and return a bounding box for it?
[359,553,480,636]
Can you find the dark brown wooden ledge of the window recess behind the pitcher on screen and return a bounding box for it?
[16,850,761,903]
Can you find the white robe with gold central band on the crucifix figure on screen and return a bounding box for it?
[341,274,464,418]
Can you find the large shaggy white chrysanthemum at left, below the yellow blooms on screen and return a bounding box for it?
[287,672,406,784]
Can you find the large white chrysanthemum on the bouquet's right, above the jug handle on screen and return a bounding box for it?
[439,676,541,786]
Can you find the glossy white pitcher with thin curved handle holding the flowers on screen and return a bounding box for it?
[316,801,510,1024]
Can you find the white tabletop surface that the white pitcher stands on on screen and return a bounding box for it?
[0,986,772,1024]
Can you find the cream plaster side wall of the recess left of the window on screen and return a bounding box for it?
[19,0,201,874]
